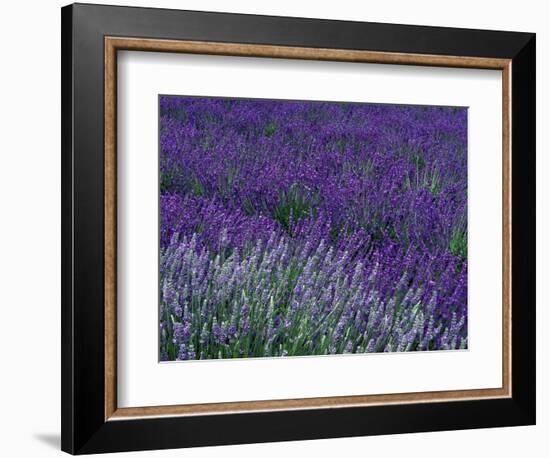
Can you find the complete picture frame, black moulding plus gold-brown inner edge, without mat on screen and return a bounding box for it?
[62,4,535,454]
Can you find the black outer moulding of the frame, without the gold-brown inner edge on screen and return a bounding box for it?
[61,4,536,454]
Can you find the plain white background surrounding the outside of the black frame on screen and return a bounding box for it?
[0,0,550,458]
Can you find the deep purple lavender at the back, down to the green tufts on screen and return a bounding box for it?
[160,97,467,257]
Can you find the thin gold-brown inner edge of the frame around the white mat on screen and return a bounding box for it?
[104,37,512,421]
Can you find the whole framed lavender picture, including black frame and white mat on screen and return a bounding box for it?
[62,4,536,454]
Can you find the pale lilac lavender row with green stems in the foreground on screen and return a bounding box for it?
[161,233,467,360]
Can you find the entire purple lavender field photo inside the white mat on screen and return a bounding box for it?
[159,96,467,361]
